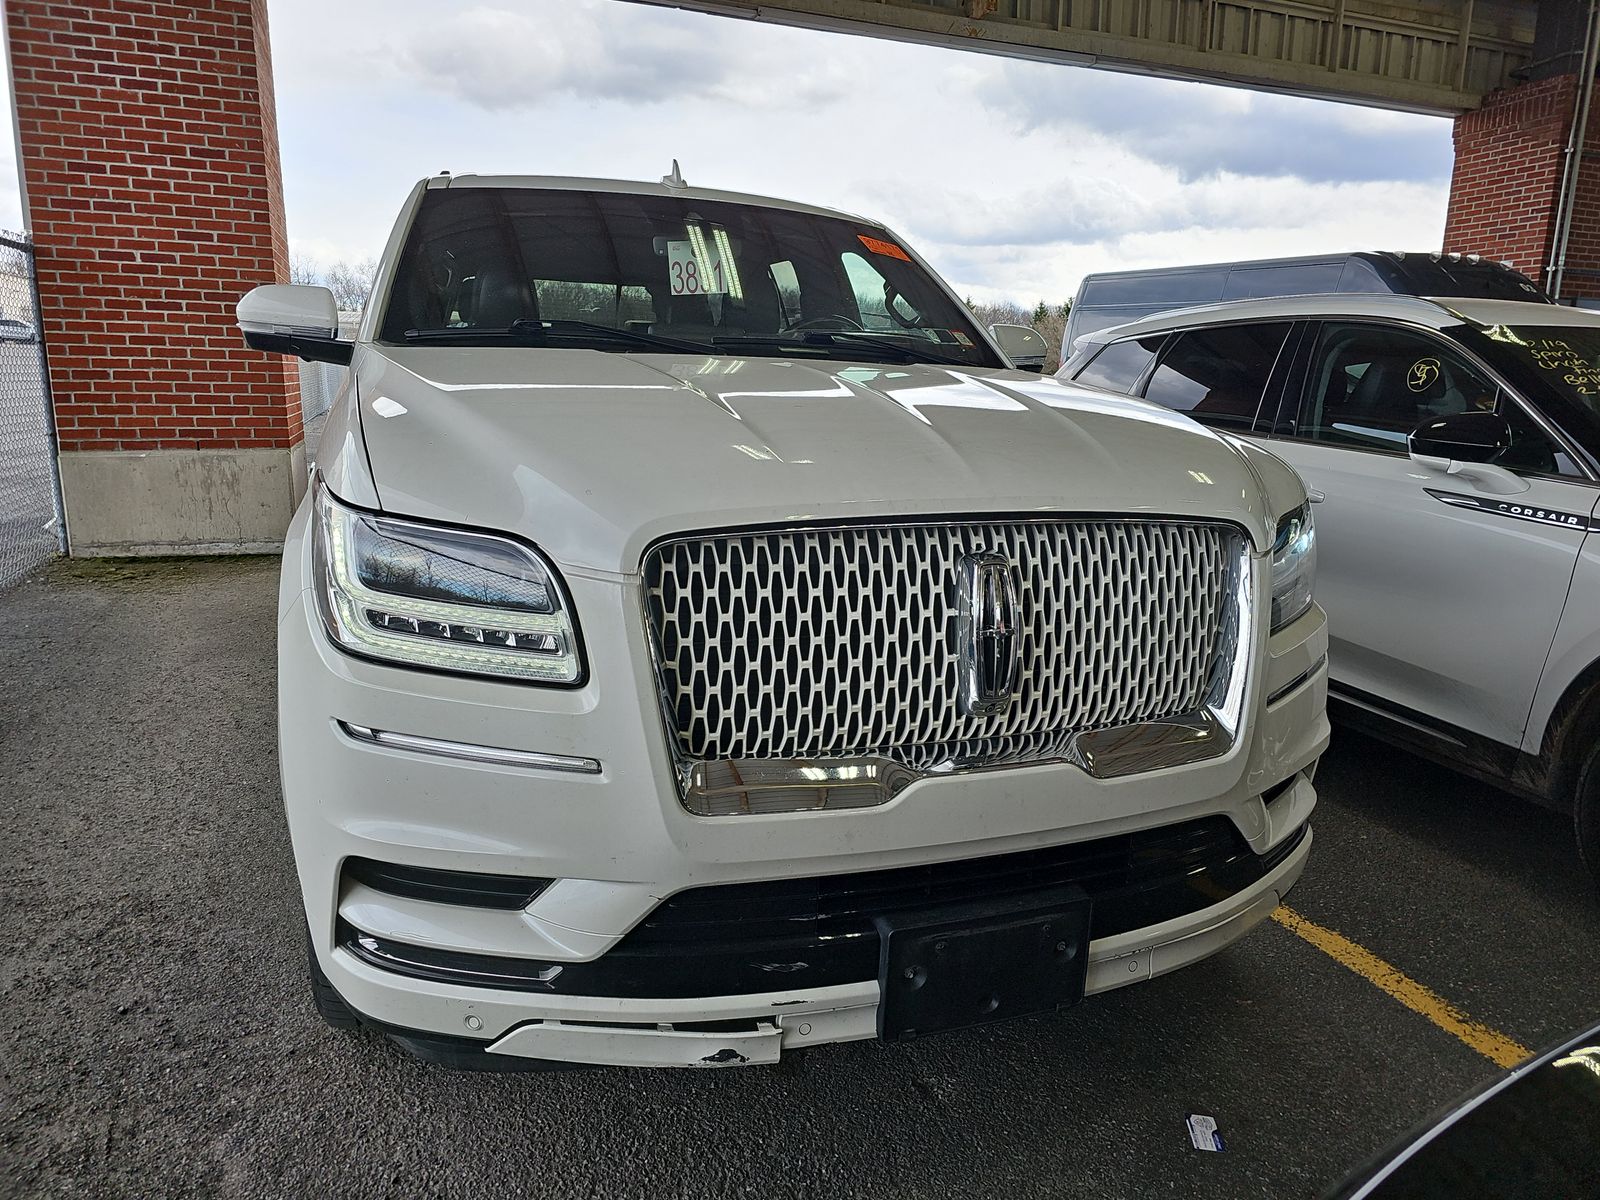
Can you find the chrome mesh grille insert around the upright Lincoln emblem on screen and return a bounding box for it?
[643,520,1240,770]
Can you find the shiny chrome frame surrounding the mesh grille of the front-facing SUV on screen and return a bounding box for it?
[637,512,1248,819]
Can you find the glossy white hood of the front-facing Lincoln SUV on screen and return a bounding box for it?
[355,346,1301,573]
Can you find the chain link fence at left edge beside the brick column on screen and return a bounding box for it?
[0,232,66,589]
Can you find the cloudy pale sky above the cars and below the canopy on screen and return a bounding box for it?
[0,0,1451,304]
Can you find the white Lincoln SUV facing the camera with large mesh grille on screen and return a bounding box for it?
[238,170,1328,1069]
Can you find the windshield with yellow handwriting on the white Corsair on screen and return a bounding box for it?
[1458,325,1600,456]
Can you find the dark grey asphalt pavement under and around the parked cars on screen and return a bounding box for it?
[0,558,1600,1200]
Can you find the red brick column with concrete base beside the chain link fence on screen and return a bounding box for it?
[5,0,306,554]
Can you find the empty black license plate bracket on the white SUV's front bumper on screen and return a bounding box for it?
[875,886,1091,1042]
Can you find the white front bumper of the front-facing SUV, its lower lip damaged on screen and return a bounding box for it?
[278,499,1328,1066]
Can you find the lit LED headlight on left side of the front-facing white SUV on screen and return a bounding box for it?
[312,485,582,683]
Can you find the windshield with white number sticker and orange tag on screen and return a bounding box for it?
[379,187,1003,366]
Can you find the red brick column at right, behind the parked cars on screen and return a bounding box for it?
[1445,75,1600,296]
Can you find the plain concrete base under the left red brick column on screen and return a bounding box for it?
[61,443,306,558]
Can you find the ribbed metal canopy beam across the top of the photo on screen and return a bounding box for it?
[630,0,1549,115]
